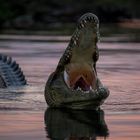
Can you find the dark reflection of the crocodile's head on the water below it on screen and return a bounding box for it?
[44,108,109,140]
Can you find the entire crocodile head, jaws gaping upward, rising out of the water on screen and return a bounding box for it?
[45,13,109,110]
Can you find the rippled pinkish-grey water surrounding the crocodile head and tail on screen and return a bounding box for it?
[0,37,140,140]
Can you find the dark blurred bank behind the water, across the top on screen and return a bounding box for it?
[0,0,140,34]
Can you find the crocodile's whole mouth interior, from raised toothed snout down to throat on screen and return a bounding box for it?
[64,13,99,93]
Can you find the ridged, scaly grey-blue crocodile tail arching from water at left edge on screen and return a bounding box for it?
[0,54,27,88]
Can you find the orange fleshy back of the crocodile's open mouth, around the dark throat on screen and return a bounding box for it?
[64,67,96,93]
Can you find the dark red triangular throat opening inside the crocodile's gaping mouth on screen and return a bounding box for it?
[74,77,90,91]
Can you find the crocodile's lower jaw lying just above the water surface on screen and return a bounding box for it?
[59,87,109,110]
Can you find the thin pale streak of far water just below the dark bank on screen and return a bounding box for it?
[0,34,140,43]
